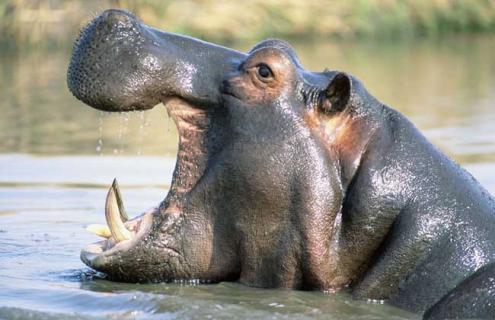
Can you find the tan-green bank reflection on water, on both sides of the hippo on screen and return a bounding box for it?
[0,36,495,162]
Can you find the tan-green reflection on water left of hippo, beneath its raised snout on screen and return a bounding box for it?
[0,47,177,154]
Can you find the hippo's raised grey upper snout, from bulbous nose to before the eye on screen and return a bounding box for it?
[67,9,245,112]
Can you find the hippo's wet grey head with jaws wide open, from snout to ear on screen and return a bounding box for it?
[68,10,372,289]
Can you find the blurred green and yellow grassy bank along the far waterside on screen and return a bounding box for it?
[0,0,495,46]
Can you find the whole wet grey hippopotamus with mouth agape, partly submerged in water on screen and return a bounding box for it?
[68,10,495,318]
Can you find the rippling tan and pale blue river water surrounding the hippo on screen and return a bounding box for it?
[0,36,495,319]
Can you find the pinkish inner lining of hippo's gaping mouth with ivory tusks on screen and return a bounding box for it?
[81,97,210,270]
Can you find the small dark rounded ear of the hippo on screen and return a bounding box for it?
[320,72,352,113]
